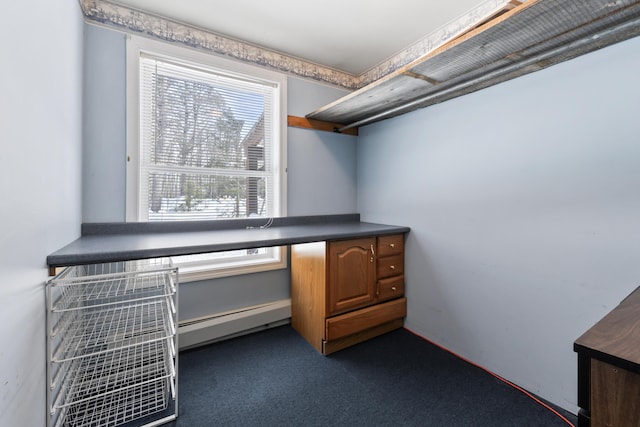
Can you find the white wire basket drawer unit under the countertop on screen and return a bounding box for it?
[46,258,178,427]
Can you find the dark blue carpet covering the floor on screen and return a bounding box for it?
[168,326,576,427]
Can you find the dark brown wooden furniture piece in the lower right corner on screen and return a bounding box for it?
[574,288,640,427]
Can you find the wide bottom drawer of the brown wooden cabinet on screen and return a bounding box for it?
[325,298,407,341]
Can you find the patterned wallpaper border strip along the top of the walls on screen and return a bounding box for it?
[80,0,506,90]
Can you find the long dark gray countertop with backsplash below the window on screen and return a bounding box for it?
[47,214,409,267]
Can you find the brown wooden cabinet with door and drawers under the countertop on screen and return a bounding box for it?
[291,234,407,354]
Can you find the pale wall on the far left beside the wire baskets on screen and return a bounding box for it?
[0,0,82,426]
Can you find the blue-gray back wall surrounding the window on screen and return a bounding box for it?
[82,25,357,319]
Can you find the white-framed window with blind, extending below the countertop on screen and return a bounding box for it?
[127,38,286,281]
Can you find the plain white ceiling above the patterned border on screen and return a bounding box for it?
[114,0,486,75]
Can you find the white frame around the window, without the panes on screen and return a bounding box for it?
[126,35,287,282]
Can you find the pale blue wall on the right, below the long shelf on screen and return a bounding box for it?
[357,38,640,412]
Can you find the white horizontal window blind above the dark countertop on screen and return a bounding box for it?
[140,55,278,221]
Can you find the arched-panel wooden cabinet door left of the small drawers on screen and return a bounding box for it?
[327,237,376,315]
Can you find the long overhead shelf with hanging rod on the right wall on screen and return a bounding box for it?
[307,0,640,128]
